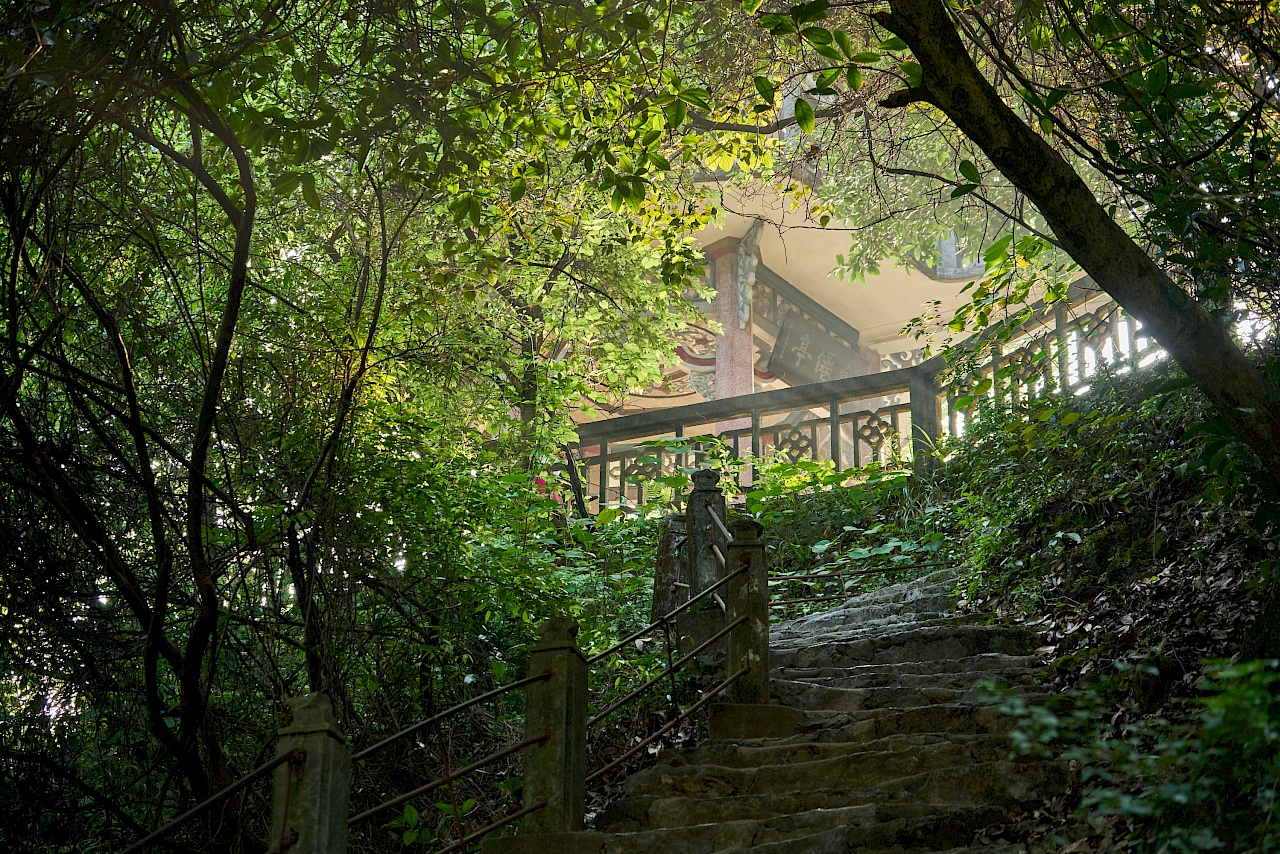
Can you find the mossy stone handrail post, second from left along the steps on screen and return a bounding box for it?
[520,617,588,834]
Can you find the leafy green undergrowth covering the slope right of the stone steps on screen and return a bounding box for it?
[748,365,1280,851]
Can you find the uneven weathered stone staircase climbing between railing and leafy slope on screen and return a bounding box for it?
[485,571,1070,854]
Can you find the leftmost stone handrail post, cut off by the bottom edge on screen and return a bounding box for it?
[270,693,351,854]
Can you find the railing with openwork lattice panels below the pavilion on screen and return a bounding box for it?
[575,279,1164,507]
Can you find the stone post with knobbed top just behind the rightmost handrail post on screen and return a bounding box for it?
[677,469,726,663]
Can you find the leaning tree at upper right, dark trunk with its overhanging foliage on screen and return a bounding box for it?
[709,0,1280,479]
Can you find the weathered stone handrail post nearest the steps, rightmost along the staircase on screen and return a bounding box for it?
[724,519,769,703]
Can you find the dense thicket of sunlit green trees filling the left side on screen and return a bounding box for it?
[0,0,753,848]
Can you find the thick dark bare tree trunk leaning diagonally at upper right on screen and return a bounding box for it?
[874,0,1280,483]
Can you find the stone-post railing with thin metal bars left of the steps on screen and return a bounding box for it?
[127,470,768,854]
